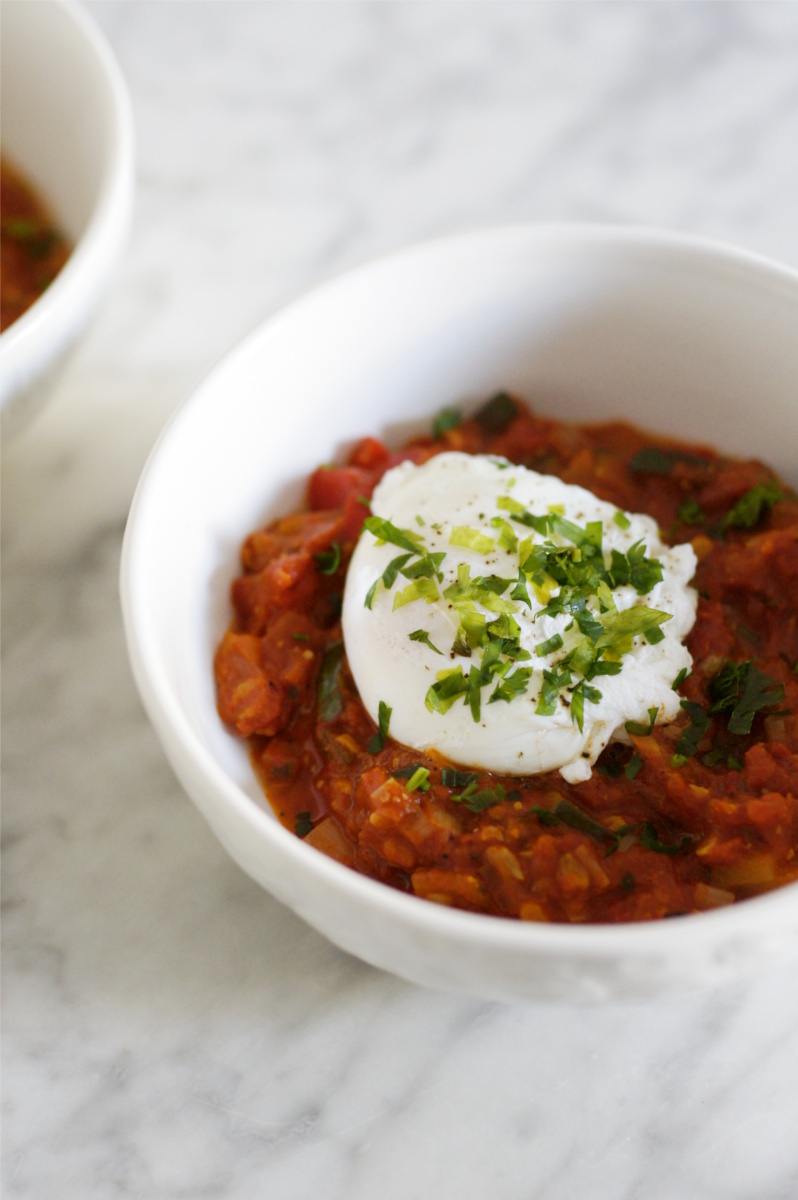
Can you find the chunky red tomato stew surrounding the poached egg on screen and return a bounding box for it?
[215,394,798,922]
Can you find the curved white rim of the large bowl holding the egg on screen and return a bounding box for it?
[120,221,798,961]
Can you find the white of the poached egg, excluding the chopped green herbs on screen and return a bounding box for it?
[343,452,697,782]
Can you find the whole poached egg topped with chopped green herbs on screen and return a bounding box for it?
[342,452,697,782]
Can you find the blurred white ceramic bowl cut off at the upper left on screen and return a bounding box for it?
[0,0,133,436]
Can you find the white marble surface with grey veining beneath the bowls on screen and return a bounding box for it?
[2,0,798,1200]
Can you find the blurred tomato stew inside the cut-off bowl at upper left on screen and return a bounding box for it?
[0,158,70,330]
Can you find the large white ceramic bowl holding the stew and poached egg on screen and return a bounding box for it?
[121,226,798,1001]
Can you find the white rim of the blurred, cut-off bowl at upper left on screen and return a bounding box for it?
[0,0,136,409]
